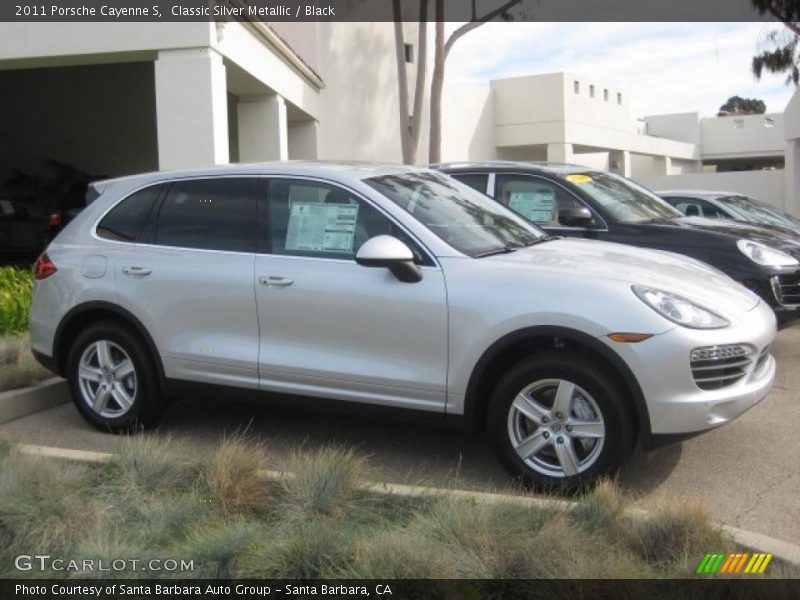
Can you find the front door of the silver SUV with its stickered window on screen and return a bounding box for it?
[255,178,447,411]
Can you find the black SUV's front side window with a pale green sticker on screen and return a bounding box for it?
[495,175,596,227]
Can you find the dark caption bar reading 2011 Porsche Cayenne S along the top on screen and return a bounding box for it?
[0,0,771,23]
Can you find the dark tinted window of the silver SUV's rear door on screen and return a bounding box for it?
[155,177,257,252]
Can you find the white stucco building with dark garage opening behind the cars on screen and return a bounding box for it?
[0,22,800,217]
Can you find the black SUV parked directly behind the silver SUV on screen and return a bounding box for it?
[433,162,800,325]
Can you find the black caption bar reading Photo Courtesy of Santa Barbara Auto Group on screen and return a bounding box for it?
[0,576,800,600]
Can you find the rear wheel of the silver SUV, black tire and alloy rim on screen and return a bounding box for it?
[67,321,164,433]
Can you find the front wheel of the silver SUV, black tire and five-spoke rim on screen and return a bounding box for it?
[487,350,636,492]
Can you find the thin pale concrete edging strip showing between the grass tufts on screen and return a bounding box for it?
[17,444,800,566]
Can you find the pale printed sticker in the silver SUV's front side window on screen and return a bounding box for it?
[286,202,358,253]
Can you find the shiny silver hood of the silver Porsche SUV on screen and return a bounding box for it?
[488,238,760,314]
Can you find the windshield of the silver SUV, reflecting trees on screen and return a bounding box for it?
[365,171,547,257]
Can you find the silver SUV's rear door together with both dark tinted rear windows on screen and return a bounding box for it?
[106,177,258,388]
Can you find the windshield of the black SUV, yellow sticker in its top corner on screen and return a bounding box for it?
[563,172,683,223]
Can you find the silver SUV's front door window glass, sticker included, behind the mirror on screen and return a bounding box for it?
[266,179,429,264]
